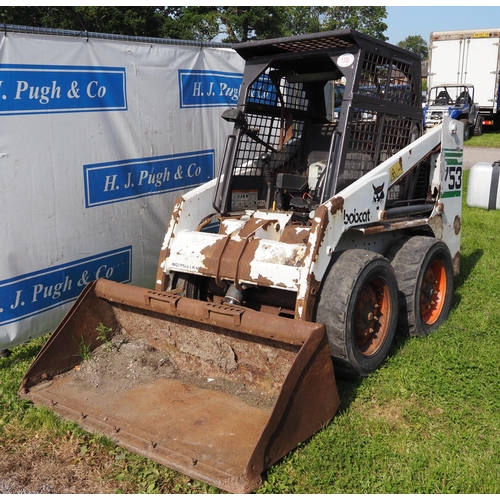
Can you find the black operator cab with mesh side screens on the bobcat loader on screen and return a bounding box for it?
[213,30,427,223]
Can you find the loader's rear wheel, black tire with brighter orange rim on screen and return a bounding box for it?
[387,236,453,337]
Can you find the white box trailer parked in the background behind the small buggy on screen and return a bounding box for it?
[427,28,500,125]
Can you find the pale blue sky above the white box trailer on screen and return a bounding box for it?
[384,5,500,45]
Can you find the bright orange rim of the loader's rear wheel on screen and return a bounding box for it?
[420,260,446,325]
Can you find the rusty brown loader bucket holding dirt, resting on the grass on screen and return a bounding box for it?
[19,279,339,493]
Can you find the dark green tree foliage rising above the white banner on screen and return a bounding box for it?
[0,5,387,43]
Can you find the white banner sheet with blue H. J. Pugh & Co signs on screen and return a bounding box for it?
[0,33,243,349]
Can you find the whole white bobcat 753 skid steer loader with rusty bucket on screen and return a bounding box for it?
[19,30,463,493]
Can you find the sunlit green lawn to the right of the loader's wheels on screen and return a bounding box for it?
[263,184,500,493]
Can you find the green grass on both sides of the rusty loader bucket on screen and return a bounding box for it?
[0,172,500,494]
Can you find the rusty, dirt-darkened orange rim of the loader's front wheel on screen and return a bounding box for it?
[354,279,390,357]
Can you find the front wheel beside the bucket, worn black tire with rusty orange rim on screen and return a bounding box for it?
[316,249,398,378]
